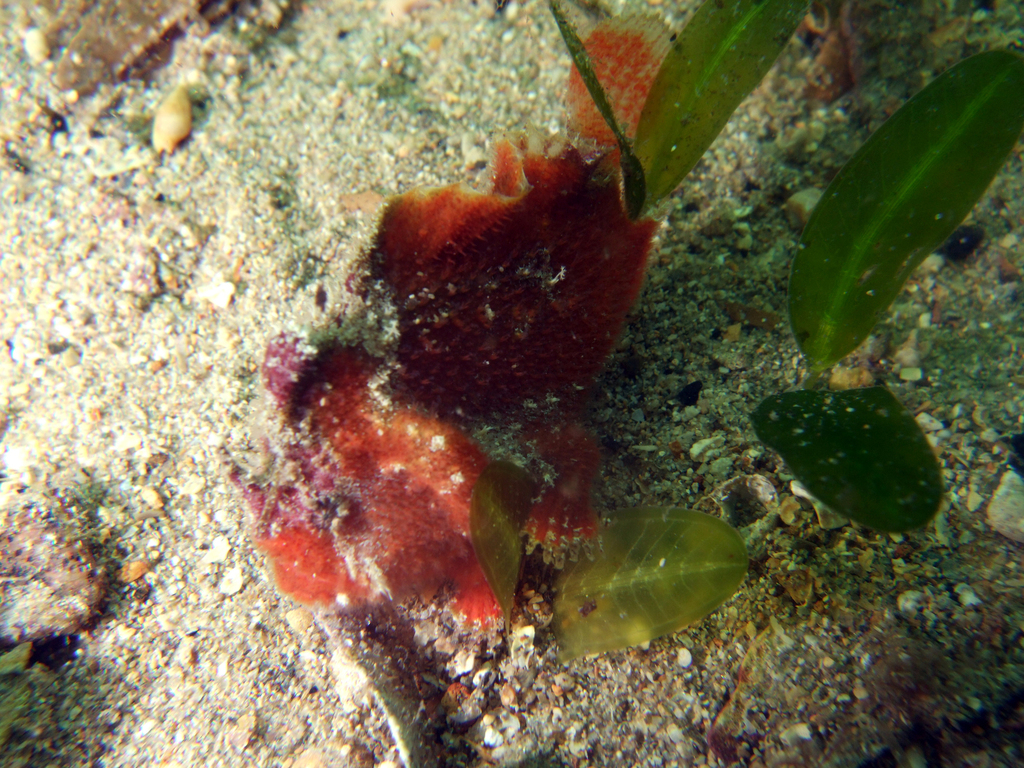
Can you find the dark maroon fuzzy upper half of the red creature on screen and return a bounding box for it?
[371,137,655,418]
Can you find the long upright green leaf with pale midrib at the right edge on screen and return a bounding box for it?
[790,50,1024,371]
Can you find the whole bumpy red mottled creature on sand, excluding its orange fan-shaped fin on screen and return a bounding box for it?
[245,140,654,621]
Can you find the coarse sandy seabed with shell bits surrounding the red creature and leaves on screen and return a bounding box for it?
[0,0,1024,768]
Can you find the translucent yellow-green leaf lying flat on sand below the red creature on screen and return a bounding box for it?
[553,507,746,660]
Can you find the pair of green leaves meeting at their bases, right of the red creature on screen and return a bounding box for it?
[753,49,1024,531]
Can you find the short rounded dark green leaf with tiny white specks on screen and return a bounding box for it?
[752,387,944,530]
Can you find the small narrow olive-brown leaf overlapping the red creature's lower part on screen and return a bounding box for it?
[469,462,536,627]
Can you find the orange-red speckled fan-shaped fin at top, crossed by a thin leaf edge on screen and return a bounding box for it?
[565,16,670,146]
